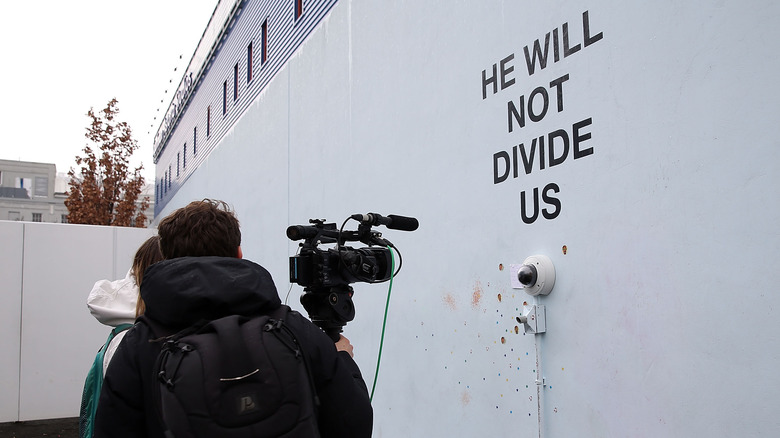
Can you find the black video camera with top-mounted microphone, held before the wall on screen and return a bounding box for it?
[287,213,419,341]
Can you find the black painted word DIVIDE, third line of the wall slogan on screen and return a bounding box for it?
[493,117,593,184]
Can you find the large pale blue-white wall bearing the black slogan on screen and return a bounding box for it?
[155,0,780,437]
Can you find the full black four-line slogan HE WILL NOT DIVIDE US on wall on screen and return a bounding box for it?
[482,11,603,224]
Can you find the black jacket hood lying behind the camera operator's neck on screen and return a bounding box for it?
[141,257,281,327]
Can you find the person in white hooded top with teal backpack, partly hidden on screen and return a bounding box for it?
[79,235,163,438]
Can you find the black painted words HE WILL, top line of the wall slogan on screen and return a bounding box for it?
[482,11,604,100]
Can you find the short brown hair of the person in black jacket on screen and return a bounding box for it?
[157,199,241,259]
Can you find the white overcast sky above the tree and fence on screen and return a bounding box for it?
[0,0,218,183]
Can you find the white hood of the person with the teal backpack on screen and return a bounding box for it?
[87,271,138,327]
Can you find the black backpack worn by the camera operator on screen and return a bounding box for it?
[155,306,320,438]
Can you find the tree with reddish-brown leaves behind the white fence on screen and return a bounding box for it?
[65,99,149,228]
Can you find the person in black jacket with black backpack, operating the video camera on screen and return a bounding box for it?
[95,199,373,438]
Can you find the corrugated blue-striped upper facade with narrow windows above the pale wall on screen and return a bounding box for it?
[154,0,336,215]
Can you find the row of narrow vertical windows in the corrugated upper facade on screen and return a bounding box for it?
[155,0,303,202]
